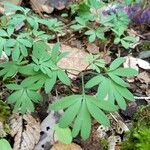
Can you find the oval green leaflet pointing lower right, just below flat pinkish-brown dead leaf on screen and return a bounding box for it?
[57,70,71,85]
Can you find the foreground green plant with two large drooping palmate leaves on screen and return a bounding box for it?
[50,57,137,139]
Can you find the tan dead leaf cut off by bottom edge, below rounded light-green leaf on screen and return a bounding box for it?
[50,143,82,150]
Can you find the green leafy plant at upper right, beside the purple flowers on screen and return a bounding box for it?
[71,0,137,49]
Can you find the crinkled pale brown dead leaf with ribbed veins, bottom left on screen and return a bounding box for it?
[10,114,40,150]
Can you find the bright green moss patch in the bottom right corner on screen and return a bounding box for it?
[121,106,150,150]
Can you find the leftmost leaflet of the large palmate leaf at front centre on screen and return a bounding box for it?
[49,95,82,111]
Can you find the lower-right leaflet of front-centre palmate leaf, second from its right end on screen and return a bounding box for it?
[86,100,110,126]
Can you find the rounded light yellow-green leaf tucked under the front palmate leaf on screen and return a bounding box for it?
[54,124,72,144]
